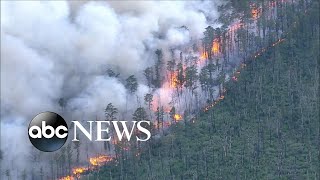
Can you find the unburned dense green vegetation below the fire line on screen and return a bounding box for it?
[88,1,320,179]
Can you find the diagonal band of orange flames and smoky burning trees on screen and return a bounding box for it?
[59,0,296,180]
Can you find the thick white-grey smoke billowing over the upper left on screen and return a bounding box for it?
[1,1,218,179]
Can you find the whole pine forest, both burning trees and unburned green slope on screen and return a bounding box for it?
[0,0,320,180]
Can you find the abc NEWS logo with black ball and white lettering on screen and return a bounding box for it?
[28,112,151,152]
